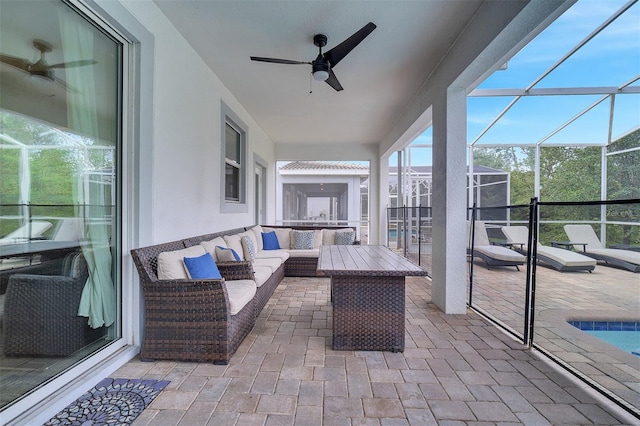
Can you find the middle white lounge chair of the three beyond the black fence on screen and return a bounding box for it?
[501,226,598,272]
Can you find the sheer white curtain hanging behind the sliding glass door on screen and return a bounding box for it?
[59,11,116,328]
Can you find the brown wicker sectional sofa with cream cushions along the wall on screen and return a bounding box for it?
[131,226,355,364]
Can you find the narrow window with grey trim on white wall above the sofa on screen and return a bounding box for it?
[220,102,248,213]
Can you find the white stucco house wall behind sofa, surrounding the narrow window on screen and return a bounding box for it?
[122,0,275,245]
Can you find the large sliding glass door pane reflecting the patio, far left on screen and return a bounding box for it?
[0,0,123,410]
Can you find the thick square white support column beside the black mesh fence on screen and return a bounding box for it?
[431,89,467,314]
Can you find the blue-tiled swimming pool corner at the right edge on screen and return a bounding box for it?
[569,321,640,357]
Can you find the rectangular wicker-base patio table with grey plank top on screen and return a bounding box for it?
[318,245,426,352]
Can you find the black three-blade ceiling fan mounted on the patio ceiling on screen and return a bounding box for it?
[251,22,376,91]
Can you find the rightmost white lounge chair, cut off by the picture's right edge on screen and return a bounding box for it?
[564,225,640,272]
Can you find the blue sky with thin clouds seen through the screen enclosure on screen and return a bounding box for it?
[390,0,640,165]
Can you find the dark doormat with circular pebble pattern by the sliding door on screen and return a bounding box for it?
[45,378,169,426]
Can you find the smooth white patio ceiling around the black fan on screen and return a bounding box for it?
[155,0,482,144]
